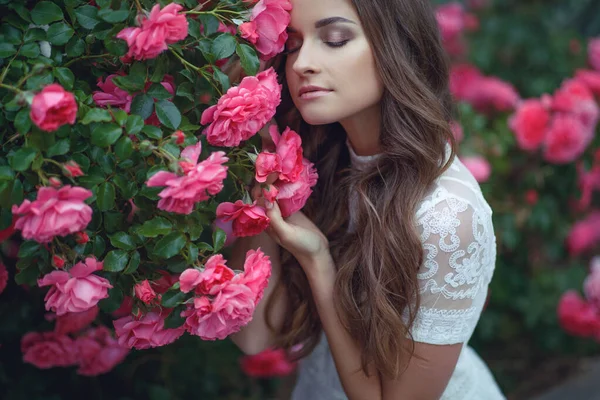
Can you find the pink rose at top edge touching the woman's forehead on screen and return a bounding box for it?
[240,0,292,60]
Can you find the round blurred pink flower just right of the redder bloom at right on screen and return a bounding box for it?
[543,114,591,164]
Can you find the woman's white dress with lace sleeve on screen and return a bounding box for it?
[292,146,505,400]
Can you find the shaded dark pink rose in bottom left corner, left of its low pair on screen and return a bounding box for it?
[21,332,77,369]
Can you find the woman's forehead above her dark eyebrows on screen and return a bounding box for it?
[290,0,359,30]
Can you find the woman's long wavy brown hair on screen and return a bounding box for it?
[267,0,455,377]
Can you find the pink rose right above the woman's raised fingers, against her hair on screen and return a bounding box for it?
[274,159,318,218]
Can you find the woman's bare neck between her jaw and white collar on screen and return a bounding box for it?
[340,104,381,156]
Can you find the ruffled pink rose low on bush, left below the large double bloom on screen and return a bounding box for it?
[113,311,185,350]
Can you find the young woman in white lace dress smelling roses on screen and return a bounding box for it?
[232,0,504,400]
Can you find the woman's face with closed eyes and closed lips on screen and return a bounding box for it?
[286,0,383,125]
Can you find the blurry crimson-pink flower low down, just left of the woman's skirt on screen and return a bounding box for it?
[240,349,296,378]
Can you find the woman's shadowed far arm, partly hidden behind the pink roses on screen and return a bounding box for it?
[229,233,285,354]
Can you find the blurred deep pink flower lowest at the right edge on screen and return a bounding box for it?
[558,290,600,337]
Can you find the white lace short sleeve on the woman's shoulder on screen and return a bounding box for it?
[411,160,496,345]
